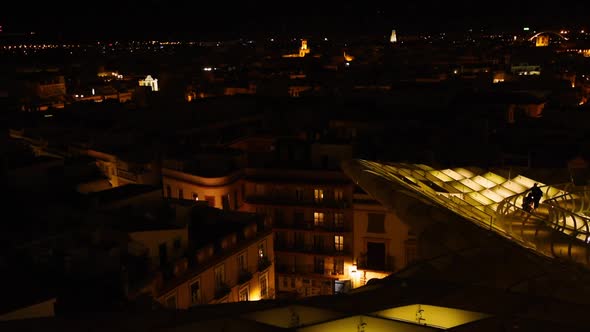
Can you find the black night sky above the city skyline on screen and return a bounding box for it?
[0,0,590,39]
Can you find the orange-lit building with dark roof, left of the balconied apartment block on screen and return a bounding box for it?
[153,202,275,309]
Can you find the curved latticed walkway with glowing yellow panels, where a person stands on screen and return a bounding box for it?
[343,160,590,267]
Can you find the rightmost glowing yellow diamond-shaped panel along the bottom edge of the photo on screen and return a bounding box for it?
[375,304,490,329]
